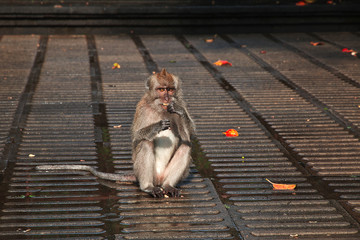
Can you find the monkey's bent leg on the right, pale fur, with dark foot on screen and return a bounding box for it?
[162,144,191,197]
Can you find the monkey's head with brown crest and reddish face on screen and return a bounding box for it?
[146,69,180,110]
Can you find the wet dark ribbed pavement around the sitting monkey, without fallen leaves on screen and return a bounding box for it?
[0,32,360,240]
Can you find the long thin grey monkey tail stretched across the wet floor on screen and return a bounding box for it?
[36,165,137,182]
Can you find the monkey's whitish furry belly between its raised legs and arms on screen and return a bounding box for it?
[154,130,179,178]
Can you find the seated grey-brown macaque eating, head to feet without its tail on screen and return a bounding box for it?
[132,69,195,197]
